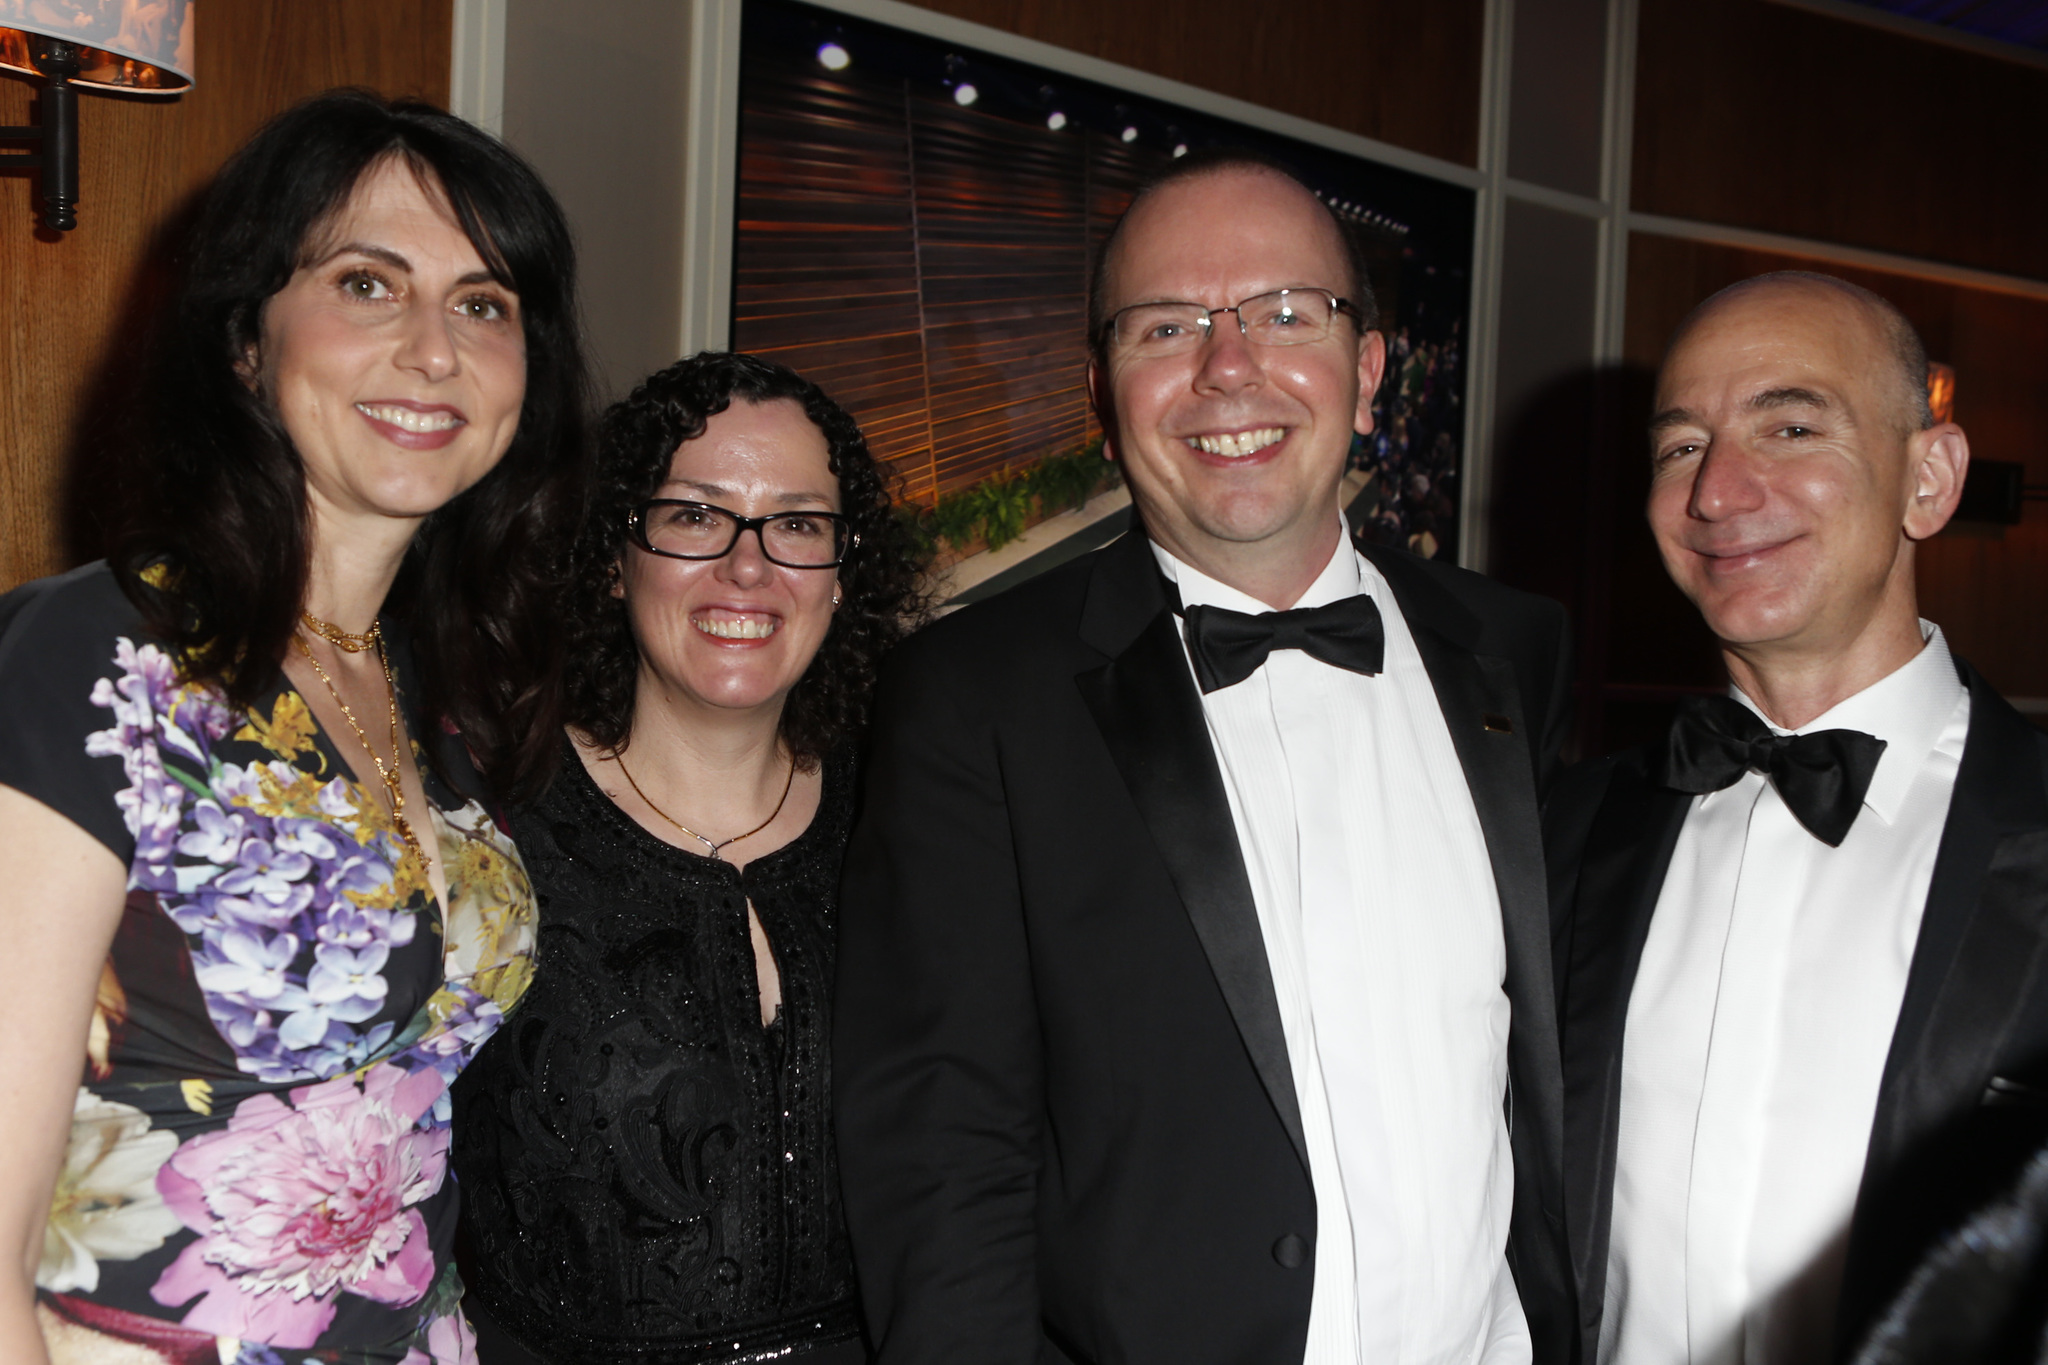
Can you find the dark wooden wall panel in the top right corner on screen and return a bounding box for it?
[1630,0,2048,278]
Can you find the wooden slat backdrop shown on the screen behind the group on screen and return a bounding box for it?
[733,48,1159,503]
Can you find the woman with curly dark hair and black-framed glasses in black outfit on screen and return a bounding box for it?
[455,352,920,1365]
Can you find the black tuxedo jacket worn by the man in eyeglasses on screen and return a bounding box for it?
[834,534,1573,1365]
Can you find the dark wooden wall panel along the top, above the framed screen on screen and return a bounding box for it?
[901,0,1485,166]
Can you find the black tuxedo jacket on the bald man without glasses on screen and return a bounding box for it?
[1544,663,2048,1361]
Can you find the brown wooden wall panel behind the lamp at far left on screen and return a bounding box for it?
[0,0,453,589]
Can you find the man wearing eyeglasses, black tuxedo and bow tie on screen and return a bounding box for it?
[836,158,1575,1365]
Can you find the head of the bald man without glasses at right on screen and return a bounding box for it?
[1649,280,1968,659]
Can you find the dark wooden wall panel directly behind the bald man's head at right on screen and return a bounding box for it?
[1608,233,2048,732]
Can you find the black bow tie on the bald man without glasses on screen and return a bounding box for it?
[1665,696,1884,847]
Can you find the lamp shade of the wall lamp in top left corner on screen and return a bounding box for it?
[0,0,193,94]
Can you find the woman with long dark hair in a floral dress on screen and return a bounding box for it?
[0,92,584,1365]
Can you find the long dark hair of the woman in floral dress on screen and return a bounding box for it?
[111,90,588,794]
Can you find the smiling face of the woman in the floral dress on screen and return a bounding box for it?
[250,160,526,534]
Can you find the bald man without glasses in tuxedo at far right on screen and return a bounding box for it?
[1544,274,2048,1365]
